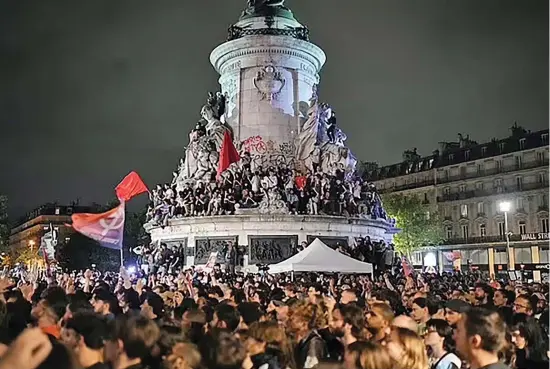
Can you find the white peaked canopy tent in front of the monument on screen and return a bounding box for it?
[269,238,372,274]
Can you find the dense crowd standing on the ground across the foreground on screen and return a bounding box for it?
[0,258,549,369]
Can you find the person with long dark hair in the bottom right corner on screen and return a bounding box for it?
[510,314,548,369]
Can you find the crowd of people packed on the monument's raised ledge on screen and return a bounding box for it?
[148,160,387,225]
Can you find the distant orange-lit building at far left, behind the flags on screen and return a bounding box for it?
[9,204,91,251]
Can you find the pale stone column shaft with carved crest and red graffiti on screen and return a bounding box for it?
[210,35,326,166]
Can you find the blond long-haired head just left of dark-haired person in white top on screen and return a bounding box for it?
[386,327,428,369]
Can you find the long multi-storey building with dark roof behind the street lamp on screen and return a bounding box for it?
[367,125,549,277]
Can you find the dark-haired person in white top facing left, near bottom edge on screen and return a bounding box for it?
[424,319,462,369]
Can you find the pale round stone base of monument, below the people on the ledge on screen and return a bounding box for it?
[145,213,395,271]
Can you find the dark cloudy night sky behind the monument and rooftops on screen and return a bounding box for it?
[0,0,548,215]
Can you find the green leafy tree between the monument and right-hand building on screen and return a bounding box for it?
[383,194,443,257]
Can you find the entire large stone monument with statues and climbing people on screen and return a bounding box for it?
[145,0,394,265]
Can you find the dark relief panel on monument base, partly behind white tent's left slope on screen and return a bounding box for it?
[248,236,298,264]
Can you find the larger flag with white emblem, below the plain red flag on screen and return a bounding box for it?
[71,202,125,250]
